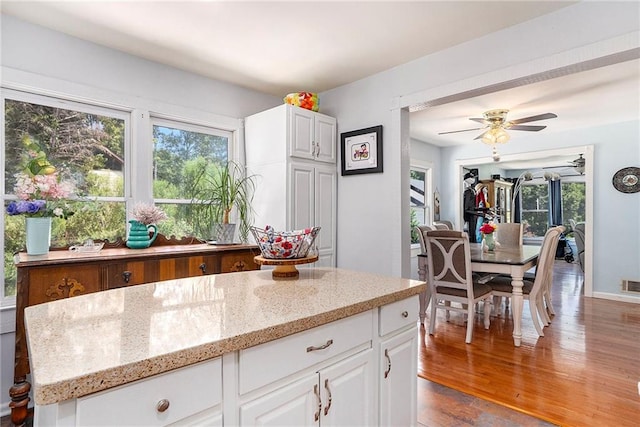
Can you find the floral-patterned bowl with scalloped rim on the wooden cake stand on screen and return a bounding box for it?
[251,225,320,259]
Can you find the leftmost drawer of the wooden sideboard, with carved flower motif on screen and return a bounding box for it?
[27,264,102,305]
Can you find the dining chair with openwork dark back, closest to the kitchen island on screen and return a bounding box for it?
[425,230,491,344]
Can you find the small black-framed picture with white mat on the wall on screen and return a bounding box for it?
[340,125,383,176]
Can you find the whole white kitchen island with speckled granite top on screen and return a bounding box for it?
[25,268,426,426]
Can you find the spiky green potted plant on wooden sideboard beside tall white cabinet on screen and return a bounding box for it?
[192,161,256,244]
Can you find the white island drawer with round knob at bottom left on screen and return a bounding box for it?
[76,358,222,426]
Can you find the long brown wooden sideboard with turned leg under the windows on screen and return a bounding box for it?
[9,236,260,426]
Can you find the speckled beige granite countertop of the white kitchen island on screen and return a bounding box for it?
[25,267,426,405]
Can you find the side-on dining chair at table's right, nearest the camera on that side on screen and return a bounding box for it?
[486,226,564,337]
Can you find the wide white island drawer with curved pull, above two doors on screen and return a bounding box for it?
[239,310,370,394]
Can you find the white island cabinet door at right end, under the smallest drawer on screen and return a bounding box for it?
[379,328,418,426]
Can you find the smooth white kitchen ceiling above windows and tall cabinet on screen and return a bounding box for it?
[0,0,575,96]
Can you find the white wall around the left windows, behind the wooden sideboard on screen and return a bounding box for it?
[0,15,282,415]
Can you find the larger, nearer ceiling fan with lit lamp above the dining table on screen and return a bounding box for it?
[438,108,558,144]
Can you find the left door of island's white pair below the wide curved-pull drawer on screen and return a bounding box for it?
[240,373,320,427]
